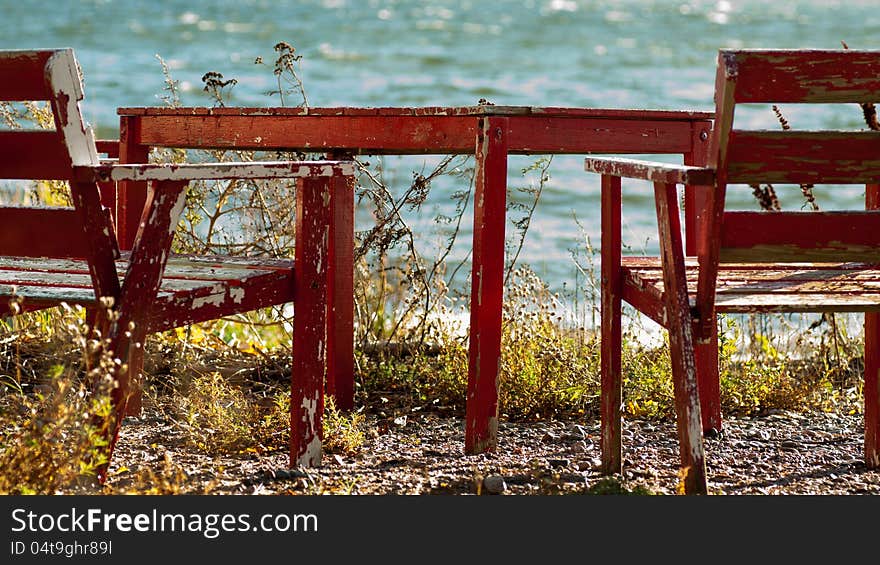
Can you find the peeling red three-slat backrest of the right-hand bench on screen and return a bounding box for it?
[697,49,880,264]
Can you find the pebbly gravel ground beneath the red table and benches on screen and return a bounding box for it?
[107,411,880,495]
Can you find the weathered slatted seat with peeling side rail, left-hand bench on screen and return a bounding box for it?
[0,252,294,332]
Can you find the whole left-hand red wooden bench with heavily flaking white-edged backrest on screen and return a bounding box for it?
[0,49,355,481]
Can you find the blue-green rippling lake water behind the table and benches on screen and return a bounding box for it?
[0,0,880,304]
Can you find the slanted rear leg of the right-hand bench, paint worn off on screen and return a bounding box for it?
[654,183,708,494]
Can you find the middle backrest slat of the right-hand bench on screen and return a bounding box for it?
[727,130,880,184]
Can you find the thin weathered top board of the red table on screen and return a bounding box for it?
[117,104,714,121]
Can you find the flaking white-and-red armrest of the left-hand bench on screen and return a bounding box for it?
[74,161,355,182]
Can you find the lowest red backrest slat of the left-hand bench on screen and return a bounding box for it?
[0,206,88,257]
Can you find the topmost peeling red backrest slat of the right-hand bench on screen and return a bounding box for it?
[720,49,880,104]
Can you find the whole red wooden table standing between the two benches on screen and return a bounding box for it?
[116,105,712,453]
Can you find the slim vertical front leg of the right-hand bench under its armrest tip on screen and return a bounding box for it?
[600,175,623,475]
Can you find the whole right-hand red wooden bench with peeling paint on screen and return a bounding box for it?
[585,50,880,493]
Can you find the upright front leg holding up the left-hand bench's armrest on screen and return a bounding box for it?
[290,177,331,467]
